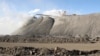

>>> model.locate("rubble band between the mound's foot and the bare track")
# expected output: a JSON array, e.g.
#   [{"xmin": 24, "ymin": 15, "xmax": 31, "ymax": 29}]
[{"xmin": 0, "ymin": 35, "xmax": 100, "ymax": 43}]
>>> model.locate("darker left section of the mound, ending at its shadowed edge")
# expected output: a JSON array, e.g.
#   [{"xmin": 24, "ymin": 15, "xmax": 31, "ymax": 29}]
[{"xmin": 14, "ymin": 17, "xmax": 54, "ymax": 35}]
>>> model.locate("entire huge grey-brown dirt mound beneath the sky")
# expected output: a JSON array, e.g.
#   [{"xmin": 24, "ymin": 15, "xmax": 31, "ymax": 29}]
[{"xmin": 14, "ymin": 14, "xmax": 100, "ymax": 37}]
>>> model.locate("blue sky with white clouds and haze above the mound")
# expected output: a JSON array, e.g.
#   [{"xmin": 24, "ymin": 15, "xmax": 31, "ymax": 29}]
[{"xmin": 0, "ymin": 0, "xmax": 100, "ymax": 34}]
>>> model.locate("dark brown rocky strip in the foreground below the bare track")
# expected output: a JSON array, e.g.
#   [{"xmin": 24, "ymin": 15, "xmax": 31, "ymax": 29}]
[{"xmin": 0, "ymin": 47, "xmax": 100, "ymax": 56}]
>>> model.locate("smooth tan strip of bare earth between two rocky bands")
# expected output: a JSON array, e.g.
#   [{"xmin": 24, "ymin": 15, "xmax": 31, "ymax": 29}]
[{"xmin": 0, "ymin": 43, "xmax": 100, "ymax": 51}]
